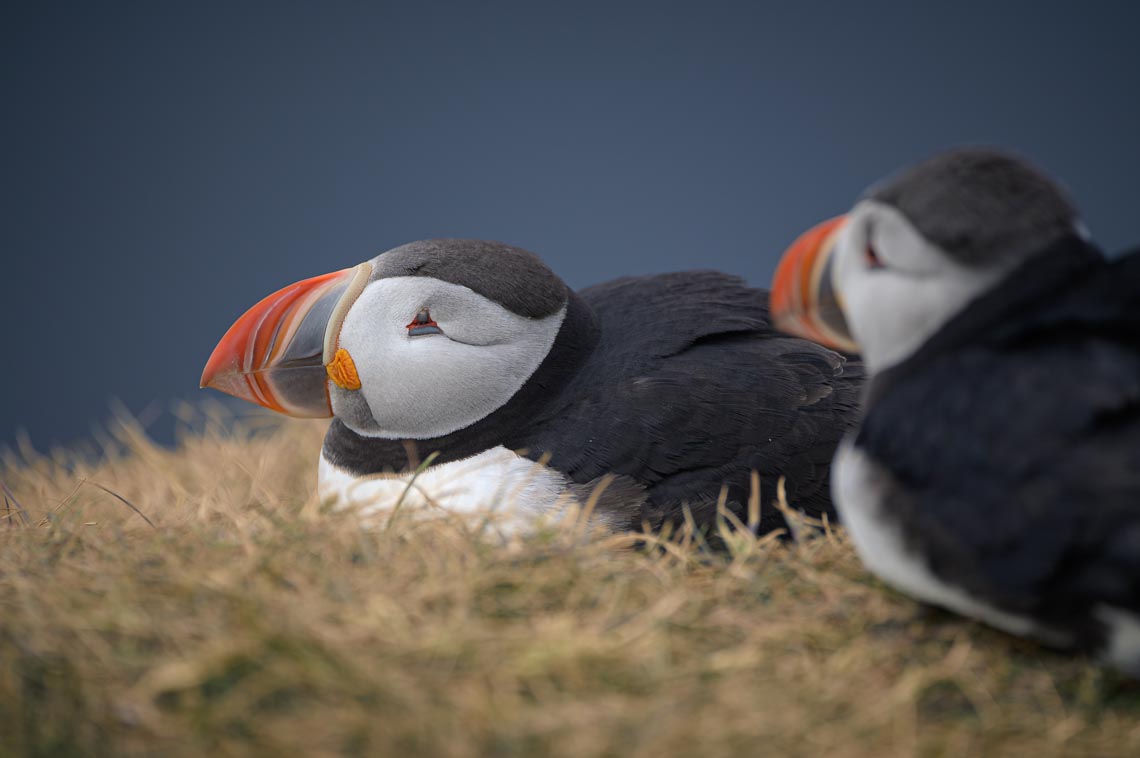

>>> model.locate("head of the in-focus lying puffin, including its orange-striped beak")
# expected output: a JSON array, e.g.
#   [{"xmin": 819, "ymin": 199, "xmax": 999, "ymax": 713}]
[{"xmin": 202, "ymin": 239, "xmax": 570, "ymax": 439}]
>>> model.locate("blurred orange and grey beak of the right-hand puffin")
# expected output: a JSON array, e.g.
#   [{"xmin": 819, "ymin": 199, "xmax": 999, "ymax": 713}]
[{"xmin": 771, "ymin": 215, "xmax": 858, "ymax": 352}]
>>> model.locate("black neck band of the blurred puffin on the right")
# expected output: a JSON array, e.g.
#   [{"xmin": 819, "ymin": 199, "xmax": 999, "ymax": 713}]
[{"xmin": 864, "ymin": 234, "xmax": 1106, "ymax": 408}]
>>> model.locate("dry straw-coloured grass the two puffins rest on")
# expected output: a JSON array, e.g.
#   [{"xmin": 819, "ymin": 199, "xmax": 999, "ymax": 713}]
[{"xmin": 0, "ymin": 410, "xmax": 1140, "ymax": 757}]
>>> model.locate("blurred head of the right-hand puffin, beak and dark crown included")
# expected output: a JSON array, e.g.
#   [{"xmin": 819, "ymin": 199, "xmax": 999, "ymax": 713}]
[{"xmin": 772, "ymin": 148, "xmax": 1086, "ymax": 372}]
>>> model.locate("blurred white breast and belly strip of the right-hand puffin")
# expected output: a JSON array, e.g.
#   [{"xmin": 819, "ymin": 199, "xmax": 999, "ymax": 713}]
[{"xmin": 831, "ymin": 438, "xmax": 1067, "ymax": 646}]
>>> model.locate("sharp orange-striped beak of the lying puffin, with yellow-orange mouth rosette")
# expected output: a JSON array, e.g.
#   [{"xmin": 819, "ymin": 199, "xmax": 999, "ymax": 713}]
[{"xmin": 201, "ymin": 263, "xmax": 372, "ymax": 418}]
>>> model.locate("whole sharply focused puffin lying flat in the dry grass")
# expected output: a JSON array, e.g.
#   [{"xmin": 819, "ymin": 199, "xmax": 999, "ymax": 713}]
[{"xmin": 201, "ymin": 239, "xmax": 863, "ymax": 532}]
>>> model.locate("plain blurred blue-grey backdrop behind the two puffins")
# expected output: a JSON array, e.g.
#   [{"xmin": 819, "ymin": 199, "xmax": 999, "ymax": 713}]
[{"xmin": 0, "ymin": 0, "xmax": 1140, "ymax": 448}]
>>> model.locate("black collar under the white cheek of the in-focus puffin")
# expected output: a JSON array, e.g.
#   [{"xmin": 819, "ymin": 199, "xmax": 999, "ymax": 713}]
[{"xmin": 323, "ymin": 292, "xmax": 600, "ymax": 475}]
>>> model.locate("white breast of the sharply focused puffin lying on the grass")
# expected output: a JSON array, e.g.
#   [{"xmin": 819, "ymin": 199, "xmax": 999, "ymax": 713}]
[{"xmin": 317, "ymin": 447, "xmax": 577, "ymax": 531}]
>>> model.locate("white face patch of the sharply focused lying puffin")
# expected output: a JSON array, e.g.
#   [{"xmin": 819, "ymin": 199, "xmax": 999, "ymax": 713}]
[{"xmin": 333, "ymin": 277, "xmax": 565, "ymax": 439}]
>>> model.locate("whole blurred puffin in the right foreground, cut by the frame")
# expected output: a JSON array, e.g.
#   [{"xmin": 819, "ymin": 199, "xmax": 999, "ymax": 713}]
[{"xmin": 772, "ymin": 147, "xmax": 1140, "ymax": 676}]
